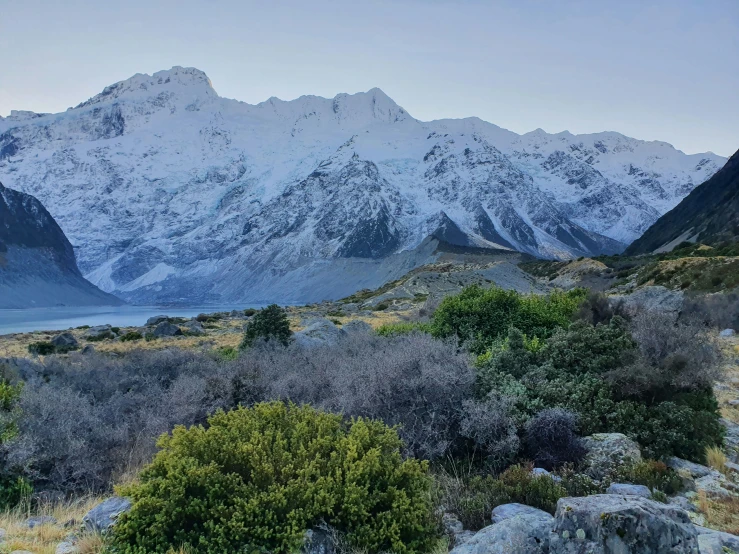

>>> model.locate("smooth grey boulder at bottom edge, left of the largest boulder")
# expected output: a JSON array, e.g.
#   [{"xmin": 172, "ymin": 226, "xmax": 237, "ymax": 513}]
[{"xmin": 451, "ymin": 512, "xmax": 553, "ymax": 554}]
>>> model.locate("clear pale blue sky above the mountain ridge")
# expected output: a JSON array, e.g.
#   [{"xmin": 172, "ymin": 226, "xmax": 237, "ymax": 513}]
[{"xmin": 0, "ymin": 0, "xmax": 739, "ymax": 156}]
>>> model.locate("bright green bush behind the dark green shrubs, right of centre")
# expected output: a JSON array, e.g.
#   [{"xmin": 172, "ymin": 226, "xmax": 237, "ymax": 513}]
[{"xmin": 433, "ymin": 285, "xmax": 585, "ymax": 353}]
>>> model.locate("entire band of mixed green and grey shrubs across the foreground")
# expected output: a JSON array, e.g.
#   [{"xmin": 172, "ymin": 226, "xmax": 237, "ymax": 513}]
[{"xmin": 0, "ymin": 287, "xmax": 723, "ymax": 554}]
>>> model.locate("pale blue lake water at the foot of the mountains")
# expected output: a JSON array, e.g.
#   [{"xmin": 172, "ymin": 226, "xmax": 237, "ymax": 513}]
[{"xmin": 0, "ymin": 305, "xmax": 259, "ymax": 335}]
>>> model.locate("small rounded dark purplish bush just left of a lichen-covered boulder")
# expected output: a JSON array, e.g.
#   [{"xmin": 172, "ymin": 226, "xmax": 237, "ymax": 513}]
[{"xmin": 524, "ymin": 408, "xmax": 585, "ymax": 471}]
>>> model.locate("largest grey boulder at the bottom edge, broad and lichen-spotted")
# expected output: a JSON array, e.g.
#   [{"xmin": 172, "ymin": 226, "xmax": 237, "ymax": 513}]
[{"xmin": 549, "ymin": 494, "xmax": 699, "ymax": 554}]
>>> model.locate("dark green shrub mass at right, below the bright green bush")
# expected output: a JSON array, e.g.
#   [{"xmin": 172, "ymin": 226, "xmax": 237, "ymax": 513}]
[{"xmin": 478, "ymin": 317, "xmax": 723, "ymax": 462}]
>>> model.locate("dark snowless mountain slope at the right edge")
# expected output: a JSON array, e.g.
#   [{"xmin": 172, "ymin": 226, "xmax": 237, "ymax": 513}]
[{"xmin": 627, "ymin": 151, "xmax": 739, "ymax": 254}]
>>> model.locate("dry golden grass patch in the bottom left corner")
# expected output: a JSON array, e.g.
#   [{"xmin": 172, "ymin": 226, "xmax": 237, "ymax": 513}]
[{"xmin": 0, "ymin": 497, "xmax": 102, "ymax": 554}]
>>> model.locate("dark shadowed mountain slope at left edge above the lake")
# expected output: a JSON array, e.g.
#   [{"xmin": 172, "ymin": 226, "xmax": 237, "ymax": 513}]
[{"xmin": 0, "ymin": 183, "xmax": 122, "ymax": 308}]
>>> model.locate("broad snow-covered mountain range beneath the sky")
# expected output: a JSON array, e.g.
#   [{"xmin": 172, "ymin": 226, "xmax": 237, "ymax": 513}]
[{"xmin": 0, "ymin": 67, "xmax": 726, "ymax": 302}]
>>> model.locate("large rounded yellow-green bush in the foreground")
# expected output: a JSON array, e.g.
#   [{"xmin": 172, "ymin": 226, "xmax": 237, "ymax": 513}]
[{"xmin": 112, "ymin": 402, "xmax": 435, "ymax": 554}]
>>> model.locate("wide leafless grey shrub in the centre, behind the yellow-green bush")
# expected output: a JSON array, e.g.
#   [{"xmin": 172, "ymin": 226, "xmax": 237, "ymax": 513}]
[{"xmin": 260, "ymin": 333, "xmax": 475, "ymax": 459}]
